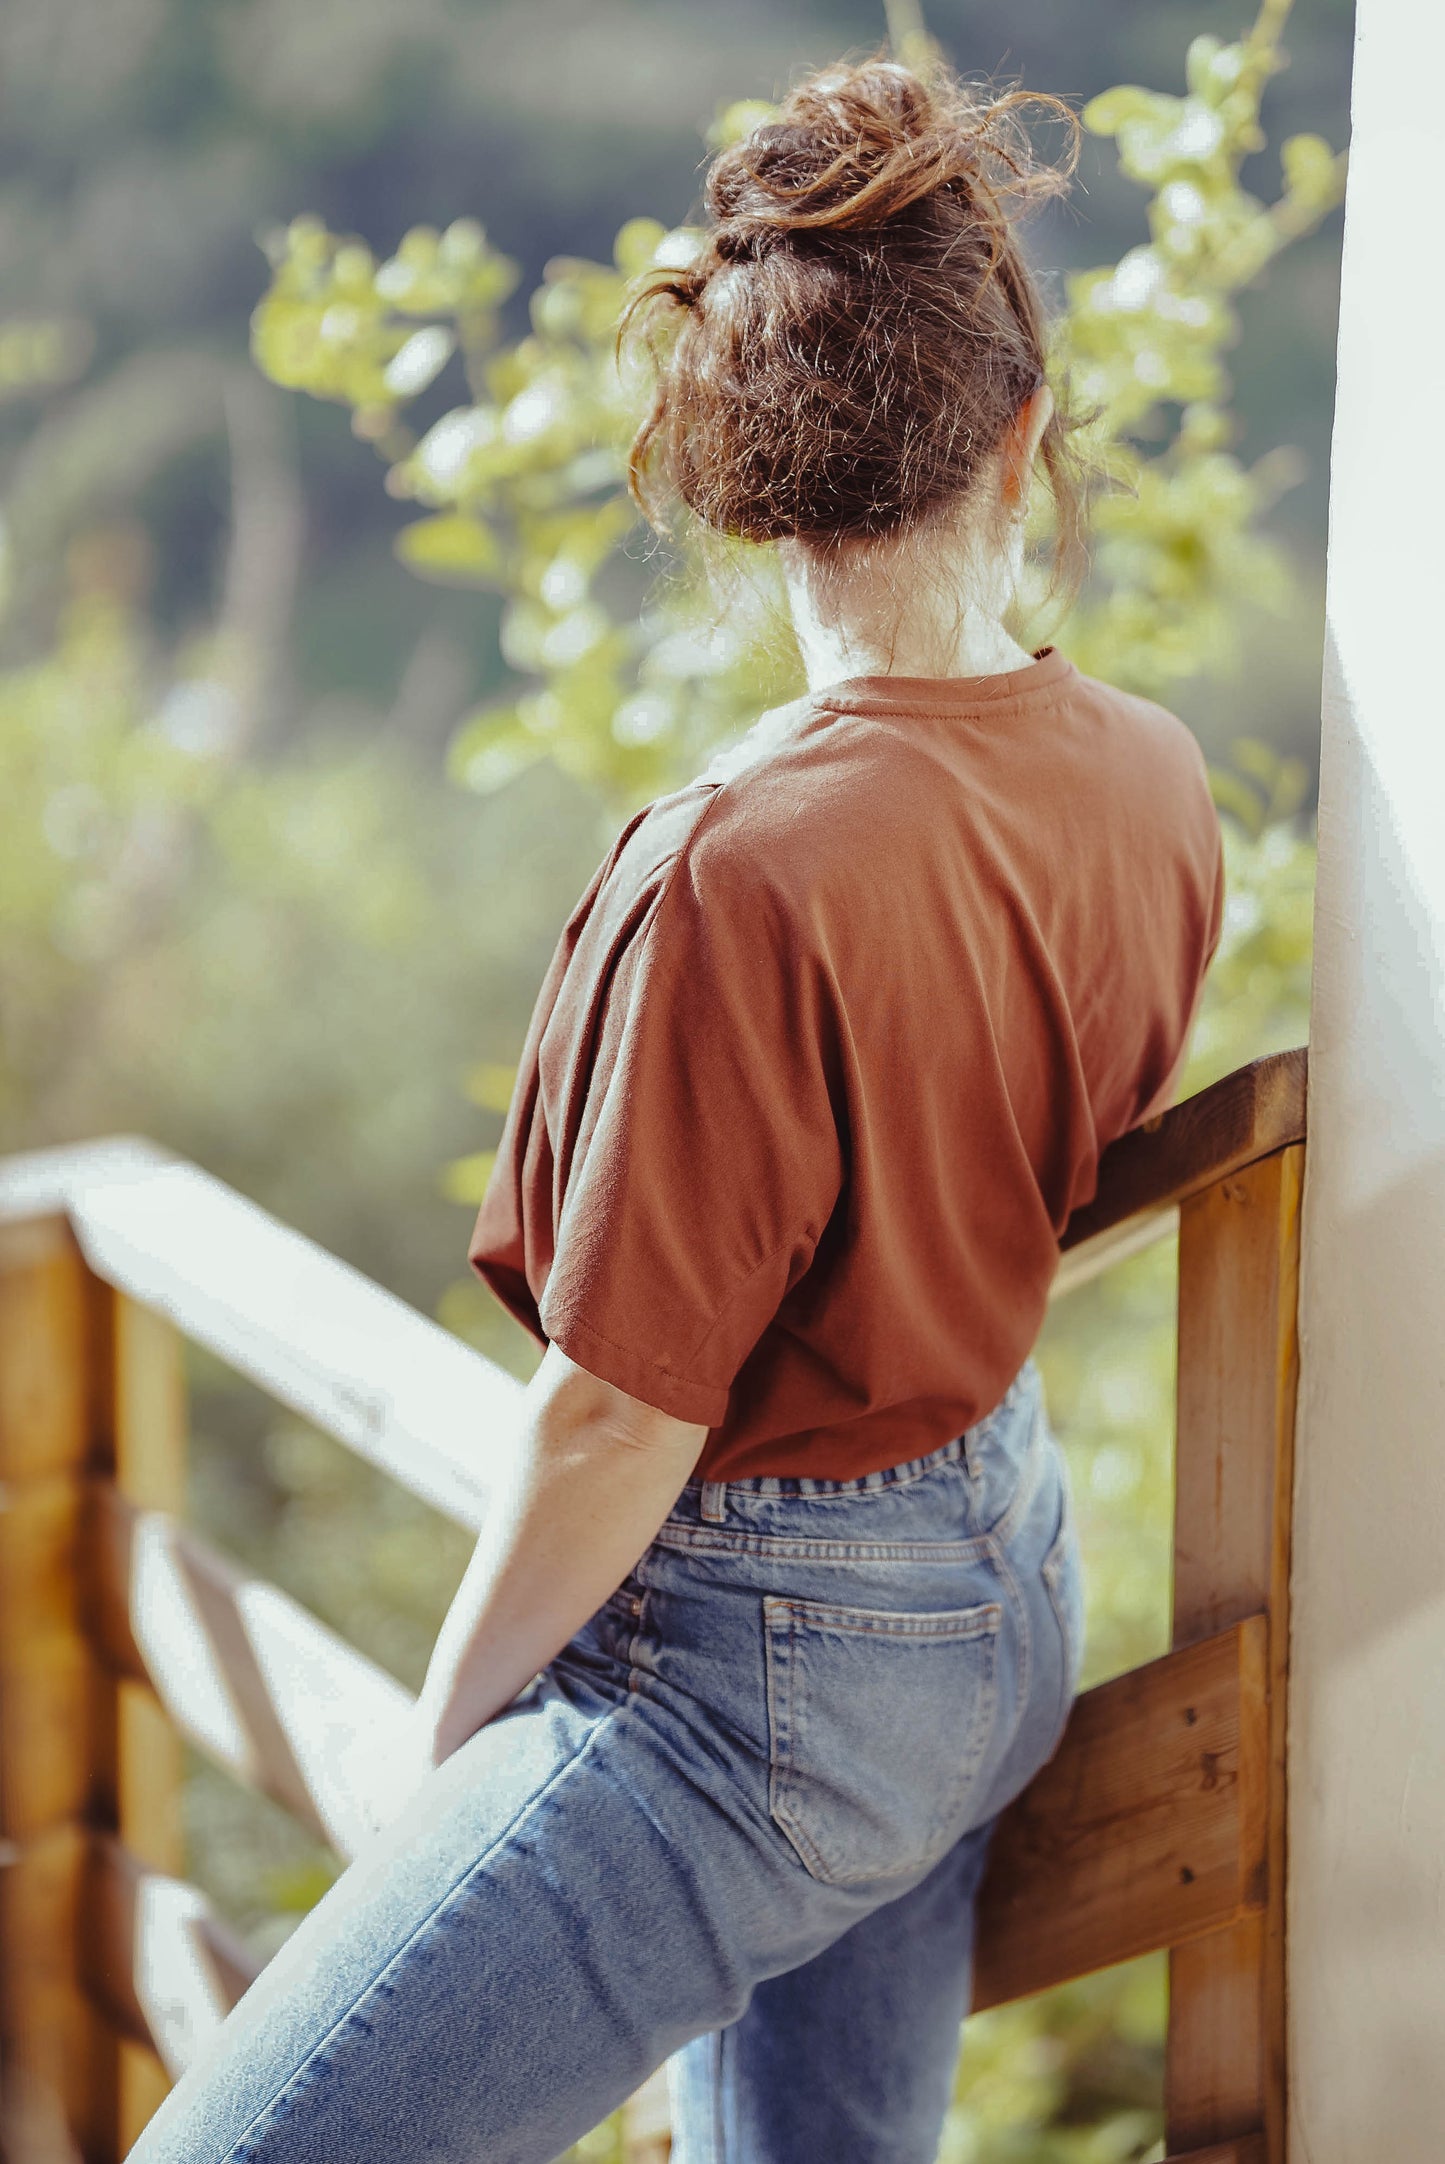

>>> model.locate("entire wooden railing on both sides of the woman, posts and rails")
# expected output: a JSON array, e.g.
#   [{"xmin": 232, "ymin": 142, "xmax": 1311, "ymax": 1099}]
[{"xmin": 0, "ymin": 1052, "xmax": 1304, "ymax": 2164}]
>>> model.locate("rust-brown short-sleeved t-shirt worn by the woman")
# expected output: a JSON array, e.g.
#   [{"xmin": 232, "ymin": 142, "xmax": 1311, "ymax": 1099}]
[{"xmin": 469, "ymin": 647, "xmax": 1224, "ymax": 1480}]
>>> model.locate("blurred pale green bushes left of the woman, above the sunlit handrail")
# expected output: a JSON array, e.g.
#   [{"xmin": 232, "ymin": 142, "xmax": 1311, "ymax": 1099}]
[{"xmin": 0, "ymin": 549, "xmax": 599, "ymax": 1307}]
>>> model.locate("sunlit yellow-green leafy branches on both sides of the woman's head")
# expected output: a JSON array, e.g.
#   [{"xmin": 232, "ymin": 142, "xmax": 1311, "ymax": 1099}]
[{"xmin": 253, "ymin": 0, "xmax": 1343, "ymax": 809}]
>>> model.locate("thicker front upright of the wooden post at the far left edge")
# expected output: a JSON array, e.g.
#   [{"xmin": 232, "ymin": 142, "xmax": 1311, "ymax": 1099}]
[{"xmin": 0, "ymin": 1220, "xmax": 119, "ymax": 2164}]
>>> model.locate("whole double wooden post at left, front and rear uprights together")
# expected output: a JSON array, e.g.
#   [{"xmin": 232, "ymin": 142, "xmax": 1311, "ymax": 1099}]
[{"xmin": 0, "ymin": 1218, "xmax": 184, "ymax": 2164}]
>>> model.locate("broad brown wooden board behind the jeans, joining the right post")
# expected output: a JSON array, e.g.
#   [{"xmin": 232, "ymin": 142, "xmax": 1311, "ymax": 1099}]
[{"xmin": 973, "ymin": 1617, "xmax": 1268, "ymax": 2008}]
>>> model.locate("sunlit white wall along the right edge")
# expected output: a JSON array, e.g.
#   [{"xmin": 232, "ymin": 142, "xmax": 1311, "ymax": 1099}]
[{"xmin": 1289, "ymin": 0, "xmax": 1445, "ymax": 2164}]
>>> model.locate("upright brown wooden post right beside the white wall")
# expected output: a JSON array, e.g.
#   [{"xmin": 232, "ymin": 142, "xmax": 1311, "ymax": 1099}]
[{"xmin": 1164, "ymin": 1143, "xmax": 1304, "ymax": 2164}]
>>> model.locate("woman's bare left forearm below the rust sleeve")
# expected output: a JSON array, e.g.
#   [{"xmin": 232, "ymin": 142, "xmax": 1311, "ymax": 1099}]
[{"xmin": 408, "ymin": 1344, "xmax": 707, "ymax": 1794}]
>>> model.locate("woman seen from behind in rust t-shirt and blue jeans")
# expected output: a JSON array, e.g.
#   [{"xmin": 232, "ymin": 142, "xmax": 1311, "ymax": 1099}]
[{"xmin": 134, "ymin": 46, "xmax": 1222, "ymax": 2164}]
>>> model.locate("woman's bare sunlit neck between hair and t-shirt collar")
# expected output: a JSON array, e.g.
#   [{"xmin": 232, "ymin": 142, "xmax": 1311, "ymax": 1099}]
[{"xmin": 781, "ymin": 515, "xmax": 1034, "ymax": 690}]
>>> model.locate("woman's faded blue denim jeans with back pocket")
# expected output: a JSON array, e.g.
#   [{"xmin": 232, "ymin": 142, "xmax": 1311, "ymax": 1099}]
[{"xmin": 132, "ymin": 1359, "xmax": 1084, "ymax": 2164}]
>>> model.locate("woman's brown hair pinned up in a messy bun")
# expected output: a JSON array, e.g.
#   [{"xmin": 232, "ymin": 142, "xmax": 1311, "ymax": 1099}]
[{"xmin": 619, "ymin": 56, "xmax": 1082, "ymax": 571}]
